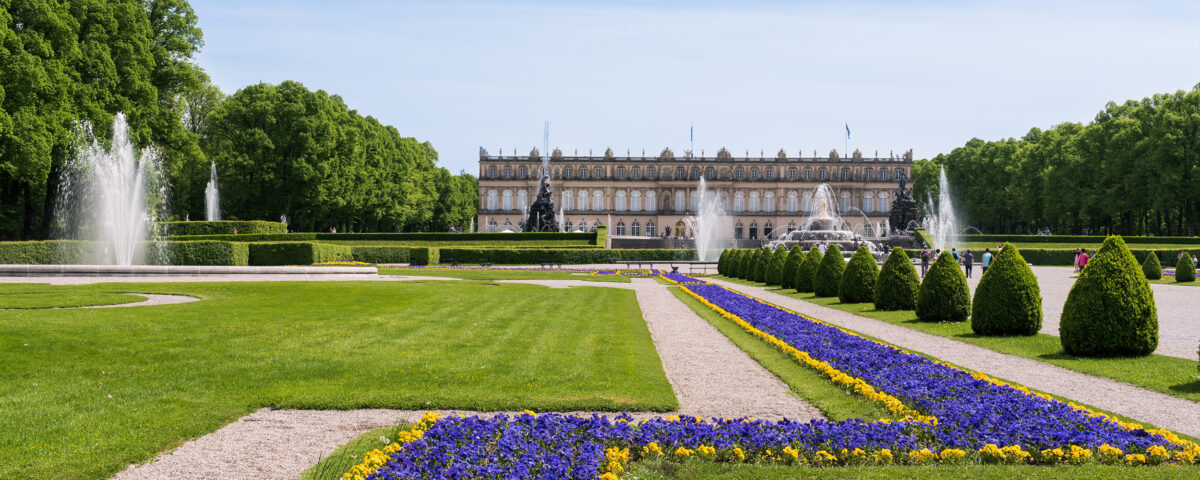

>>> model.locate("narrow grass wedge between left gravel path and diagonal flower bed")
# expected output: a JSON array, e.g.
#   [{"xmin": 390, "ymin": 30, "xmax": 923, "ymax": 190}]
[{"xmin": 671, "ymin": 287, "xmax": 892, "ymax": 420}]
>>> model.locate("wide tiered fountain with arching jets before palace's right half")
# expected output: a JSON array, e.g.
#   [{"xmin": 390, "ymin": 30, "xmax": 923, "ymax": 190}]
[{"xmin": 767, "ymin": 184, "xmax": 887, "ymax": 259}]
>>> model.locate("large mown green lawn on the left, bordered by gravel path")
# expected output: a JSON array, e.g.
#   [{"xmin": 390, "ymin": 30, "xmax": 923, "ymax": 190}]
[{"xmin": 0, "ymin": 282, "xmax": 677, "ymax": 479}]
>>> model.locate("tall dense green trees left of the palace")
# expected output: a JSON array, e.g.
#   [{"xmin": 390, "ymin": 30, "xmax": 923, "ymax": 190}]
[{"xmin": 0, "ymin": 0, "xmax": 476, "ymax": 240}]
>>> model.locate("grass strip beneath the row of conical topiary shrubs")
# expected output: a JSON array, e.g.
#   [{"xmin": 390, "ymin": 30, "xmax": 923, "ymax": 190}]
[{"xmin": 721, "ymin": 277, "xmax": 1200, "ymax": 402}]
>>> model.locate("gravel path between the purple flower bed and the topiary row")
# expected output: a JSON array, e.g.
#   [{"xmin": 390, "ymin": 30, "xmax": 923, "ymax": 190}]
[{"xmin": 713, "ymin": 280, "xmax": 1200, "ymax": 437}]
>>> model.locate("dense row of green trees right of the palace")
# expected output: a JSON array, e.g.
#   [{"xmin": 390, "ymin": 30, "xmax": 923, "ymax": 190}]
[{"xmin": 913, "ymin": 85, "xmax": 1200, "ymax": 235}]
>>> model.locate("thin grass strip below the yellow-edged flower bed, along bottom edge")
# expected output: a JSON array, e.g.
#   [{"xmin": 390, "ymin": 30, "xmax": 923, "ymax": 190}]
[{"xmin": 630, "ymin": 461, "xmax": 1200, "ymax": 480}]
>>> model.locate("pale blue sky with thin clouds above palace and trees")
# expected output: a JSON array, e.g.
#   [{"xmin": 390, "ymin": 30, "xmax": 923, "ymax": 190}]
[{"xmin": 191, "ymin": 0, "xmax": 1200, "ymax": 173}]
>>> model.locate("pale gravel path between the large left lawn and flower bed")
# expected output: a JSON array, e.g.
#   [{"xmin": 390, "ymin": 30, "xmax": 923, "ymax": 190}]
[{"xmin": 114, "ymin": 277, "xmax": 822, "ymax": 480}]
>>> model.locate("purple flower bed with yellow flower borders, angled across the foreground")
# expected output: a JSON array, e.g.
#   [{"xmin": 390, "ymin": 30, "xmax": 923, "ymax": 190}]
[{"xmin": 344, "ymin": 267, "xmax": 1200, "ymax": 480}]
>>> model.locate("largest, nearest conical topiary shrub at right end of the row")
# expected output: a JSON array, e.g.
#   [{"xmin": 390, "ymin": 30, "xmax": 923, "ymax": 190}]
[{"xmin": 1058, "ymin": 236, "xmax": 1158, "ymax": 356}]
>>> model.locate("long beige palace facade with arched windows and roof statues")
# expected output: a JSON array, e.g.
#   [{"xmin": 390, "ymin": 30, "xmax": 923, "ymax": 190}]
[{"xmin": 476, "ymin": 148, "xmax": 912, "ymax": 239}]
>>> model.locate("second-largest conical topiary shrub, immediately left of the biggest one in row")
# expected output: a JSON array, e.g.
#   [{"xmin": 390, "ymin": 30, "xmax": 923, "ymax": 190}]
[{"xmin": 971, "ymin": 244, "xmax": 1042, "ymax": 335}]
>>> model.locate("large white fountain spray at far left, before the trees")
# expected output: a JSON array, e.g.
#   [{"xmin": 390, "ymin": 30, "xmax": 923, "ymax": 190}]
[{"xmin": 55, "ymin": 114, "xmax": 167, "ymax": 265}]
